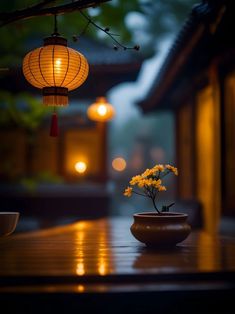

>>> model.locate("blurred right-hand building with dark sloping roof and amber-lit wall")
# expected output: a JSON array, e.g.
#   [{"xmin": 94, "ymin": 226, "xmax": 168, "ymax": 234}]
[{"xmin": 139, "ymin": 0, "xmax": 235, "ymax": 232}]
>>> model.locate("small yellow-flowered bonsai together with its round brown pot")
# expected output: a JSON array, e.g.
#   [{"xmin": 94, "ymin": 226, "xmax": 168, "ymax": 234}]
[{"xmin": 124, "ymin": 164, "xmax": 191, "ymax": 246}]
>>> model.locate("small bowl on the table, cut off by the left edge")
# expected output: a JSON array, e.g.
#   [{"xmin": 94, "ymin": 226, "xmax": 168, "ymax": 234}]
[{"xmin": 0, "ymin": 212, "xmax": 20, "ymax": 236}]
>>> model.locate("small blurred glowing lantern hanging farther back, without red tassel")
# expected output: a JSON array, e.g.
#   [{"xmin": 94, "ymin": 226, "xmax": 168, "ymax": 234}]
[{"xmin": 87, "ymin": 97, "xmax": 115, "ymax": 122}]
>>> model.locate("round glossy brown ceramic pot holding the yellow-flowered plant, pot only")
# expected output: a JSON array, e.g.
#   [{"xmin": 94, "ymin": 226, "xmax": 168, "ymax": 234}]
[{"xmin": 130, "ymin": 212, "xmax": 191, "ymax": 247}]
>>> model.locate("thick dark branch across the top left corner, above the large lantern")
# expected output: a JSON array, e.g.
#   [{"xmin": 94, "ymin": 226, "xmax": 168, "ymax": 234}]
[{"xmin": 0, "ymin": 0, "xmax": 110, "ymax": 27}]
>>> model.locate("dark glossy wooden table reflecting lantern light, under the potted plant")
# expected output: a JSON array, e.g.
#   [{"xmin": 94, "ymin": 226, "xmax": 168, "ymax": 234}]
[{"xmin": 0, "ymin": 218, "xmax": 235, "ymax": 314}]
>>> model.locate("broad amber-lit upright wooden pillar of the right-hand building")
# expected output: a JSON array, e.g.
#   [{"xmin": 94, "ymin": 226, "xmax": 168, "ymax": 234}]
[{"xmin": 195, "ymin": 66, "xmax": 221, "ymax": 233}]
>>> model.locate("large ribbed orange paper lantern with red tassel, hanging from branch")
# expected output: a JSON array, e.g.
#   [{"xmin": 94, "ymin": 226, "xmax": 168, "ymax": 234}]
[{"xmin": 23, "ymin": 16, "xmax": 89, "ymax": 136}]
